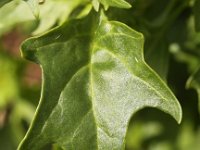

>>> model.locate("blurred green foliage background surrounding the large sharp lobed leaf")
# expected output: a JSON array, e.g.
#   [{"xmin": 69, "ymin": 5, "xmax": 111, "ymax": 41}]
[{"xmin": 0, "ymin": 0, "xmax": 200, "ymax": 150}]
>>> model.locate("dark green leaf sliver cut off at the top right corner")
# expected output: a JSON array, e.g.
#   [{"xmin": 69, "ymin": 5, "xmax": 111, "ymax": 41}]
[{"xmin": 194, "ymin": 0, "xmax": 200, "ymax": 32}]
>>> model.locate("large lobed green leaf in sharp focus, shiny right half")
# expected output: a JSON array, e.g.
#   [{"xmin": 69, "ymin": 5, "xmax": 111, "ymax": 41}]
[{"xmin": 19, "ymin": 12, "xmax": 182, "ymax": 150}]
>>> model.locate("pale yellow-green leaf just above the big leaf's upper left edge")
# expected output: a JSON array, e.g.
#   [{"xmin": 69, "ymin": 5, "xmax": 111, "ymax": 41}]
[{"xmin": 34, "ymin": 0, "xmax": 87, "ymax": 34}]
